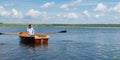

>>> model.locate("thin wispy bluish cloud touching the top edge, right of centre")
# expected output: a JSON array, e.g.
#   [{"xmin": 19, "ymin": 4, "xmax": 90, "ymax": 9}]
[{"xmin": 60, "ymin": 0, "xmax": 82, "ymax": 10}]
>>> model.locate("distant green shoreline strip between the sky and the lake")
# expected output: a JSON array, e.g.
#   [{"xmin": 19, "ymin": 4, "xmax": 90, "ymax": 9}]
[{"xmin": 0, "ymin": 24, "xmax": 120, "ymax": 28}]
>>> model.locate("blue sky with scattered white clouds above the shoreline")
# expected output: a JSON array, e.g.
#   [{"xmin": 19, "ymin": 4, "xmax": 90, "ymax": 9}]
[{"xmin": 0, "ymin": 0, "xmax": 120, "ymax": 24}]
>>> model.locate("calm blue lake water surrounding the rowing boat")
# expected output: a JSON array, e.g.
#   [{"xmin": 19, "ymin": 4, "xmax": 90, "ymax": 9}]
[{"xmin": 0, "ymin": 27, "xmax": 120, "ymax": 60}]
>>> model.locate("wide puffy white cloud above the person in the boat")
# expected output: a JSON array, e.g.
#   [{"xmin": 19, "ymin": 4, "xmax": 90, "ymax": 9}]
[{"xmin": 26, "ymin": 9, "xmax": 47, "ymax": 18}]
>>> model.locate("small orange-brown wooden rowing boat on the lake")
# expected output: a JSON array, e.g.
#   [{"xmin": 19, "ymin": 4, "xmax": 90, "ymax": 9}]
[{"xmin": 18, "ymin": 32, "xmax": 49, "ymax": 44}]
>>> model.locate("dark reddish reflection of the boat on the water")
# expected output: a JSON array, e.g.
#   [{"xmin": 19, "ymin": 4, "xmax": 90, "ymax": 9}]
[{"xmin": 20, "ymin": 40, "xmax": 49, "ymax": 50}]
